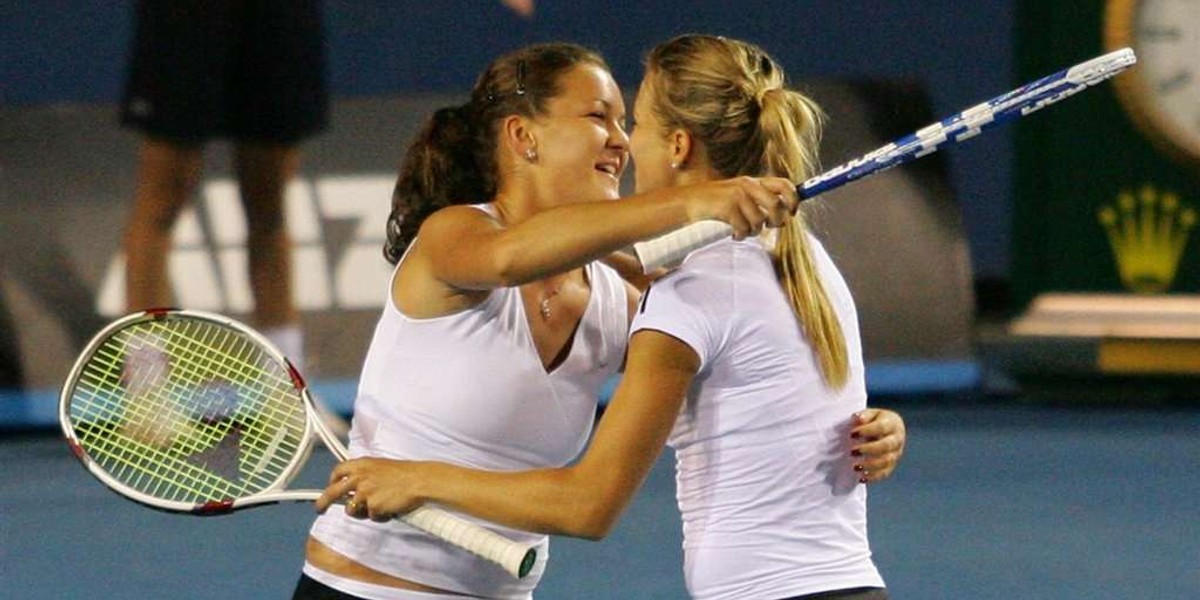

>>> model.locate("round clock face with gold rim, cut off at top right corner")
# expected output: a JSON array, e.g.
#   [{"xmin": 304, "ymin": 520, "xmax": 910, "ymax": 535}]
[{"xmin": 1105, "ymin": 0, "xmax": 1200, "ymax": 164}]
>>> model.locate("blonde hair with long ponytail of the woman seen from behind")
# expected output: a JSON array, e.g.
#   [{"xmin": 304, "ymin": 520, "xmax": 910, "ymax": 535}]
[{"xmin": 647, "ymin": 35, "xmax": 850, "ymax": 388}]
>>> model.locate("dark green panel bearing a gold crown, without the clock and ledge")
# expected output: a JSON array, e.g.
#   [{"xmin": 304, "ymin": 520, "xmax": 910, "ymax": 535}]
[{"xmin": 1010, "ymin": 0, "xmax": 1200, "ymax": 313}]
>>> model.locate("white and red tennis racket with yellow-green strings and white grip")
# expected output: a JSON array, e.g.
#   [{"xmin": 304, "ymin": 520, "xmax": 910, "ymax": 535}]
[{"xmin": 59, "ymin": 308, "xmax": 536, "ymax": 577}]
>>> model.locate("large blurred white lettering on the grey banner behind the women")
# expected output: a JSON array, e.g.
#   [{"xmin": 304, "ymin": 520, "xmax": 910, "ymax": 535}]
[{"xmin": 96, "ymin": 175, "xmax": 394, "ymax": 317}]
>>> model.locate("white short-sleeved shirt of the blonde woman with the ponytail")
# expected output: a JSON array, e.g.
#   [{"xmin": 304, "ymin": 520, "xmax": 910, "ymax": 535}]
[{"xmin": 632, "ymin": 236, "xmax": 883, "ymax": 600}]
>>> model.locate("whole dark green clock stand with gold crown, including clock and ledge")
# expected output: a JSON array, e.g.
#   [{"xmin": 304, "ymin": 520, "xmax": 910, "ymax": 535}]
[{"xmin": 1008, "ymin": 0, "xmax": 1200, "ymax": 374}]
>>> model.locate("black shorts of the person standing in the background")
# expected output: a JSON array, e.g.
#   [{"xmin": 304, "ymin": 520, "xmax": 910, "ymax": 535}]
[{"xmin": 121, "ymin": 0, "xmax": 329, "ymax": 144}]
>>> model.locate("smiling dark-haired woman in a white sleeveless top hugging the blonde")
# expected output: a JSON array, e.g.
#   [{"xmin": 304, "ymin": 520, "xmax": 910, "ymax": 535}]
[{"xmin": 295, "ymin": 43, "xmax": 797, "ymax": 599}]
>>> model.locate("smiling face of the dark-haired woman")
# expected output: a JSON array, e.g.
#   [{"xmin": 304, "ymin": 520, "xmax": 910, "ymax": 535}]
[{"xmin": 529, "ymin": 64, "xmax": 629, "ymax": 202}]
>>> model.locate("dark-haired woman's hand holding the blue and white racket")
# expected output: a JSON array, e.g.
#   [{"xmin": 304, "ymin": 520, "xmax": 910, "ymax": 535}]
[{"xmin": 679, "ymin": 176, "xmax": 800, "ymax": 240}]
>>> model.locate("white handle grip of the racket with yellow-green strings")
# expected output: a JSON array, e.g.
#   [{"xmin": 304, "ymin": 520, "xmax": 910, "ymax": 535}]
[{"xmin": 400, "ymin": 506, "xmax": 538, "ymax": 578}]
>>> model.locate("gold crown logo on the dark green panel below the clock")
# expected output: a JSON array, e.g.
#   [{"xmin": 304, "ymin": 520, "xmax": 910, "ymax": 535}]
[{"xmin": 1097, "ymin": 186, "xmax": 1196, "ymax": 294}]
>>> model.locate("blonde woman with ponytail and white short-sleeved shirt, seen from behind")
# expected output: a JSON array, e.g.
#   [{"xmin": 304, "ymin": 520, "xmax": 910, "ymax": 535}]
[{"xmin": 318, "ymin": 35, "xmax": 904, "ymax": 600}]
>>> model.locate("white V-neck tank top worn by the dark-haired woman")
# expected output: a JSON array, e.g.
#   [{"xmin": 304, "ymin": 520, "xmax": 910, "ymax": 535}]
[{"xmin": 311, "ymin": 205, "xmax": 629, "ymax": 599}]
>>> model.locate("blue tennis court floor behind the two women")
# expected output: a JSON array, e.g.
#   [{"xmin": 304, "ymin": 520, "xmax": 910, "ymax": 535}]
[{"xmin": 0, "ymin": 397, "xmax": 1200, "ymax": 600}]
